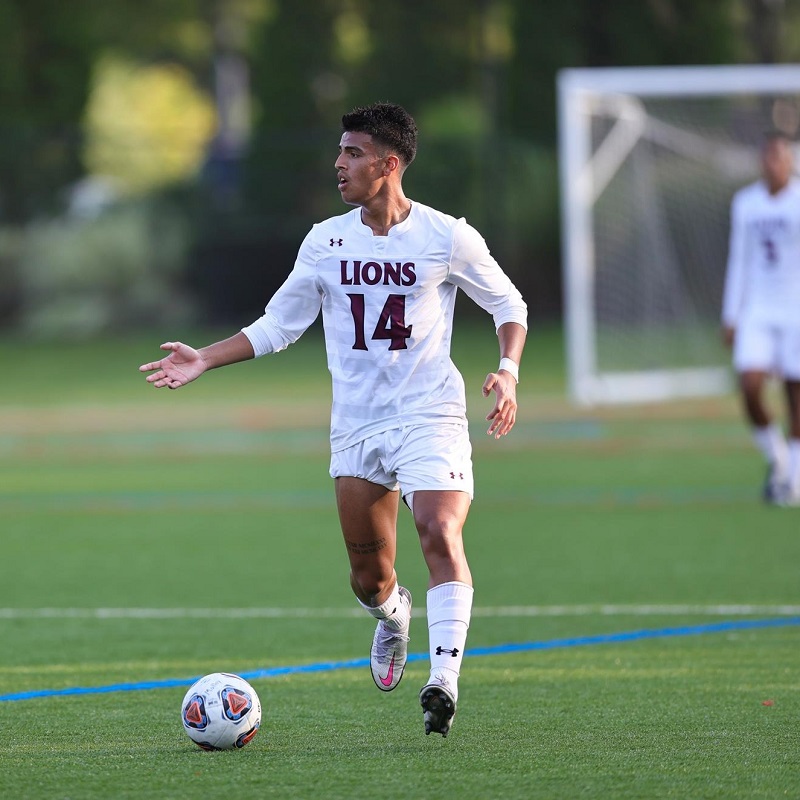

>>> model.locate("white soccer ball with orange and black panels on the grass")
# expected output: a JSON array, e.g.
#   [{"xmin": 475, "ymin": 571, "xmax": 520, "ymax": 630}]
[{"xmin": 181, "ymin": 672, "xmax": 261, "ymax": 750}]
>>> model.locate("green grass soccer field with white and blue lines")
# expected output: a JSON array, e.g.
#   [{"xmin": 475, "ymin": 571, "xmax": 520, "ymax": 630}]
[{"xmin": 0, "ymin": 324, "xmax": 800, "ymax": 800}]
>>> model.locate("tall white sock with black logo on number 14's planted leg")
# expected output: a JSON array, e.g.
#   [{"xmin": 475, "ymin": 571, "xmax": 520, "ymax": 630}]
[{"xmin": 428, "ymin": 581, "xmax": 473, "ymax": 698}]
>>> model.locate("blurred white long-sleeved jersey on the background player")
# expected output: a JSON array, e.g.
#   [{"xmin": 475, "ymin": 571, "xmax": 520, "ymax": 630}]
[{"xmin": 722, "ymin": 178, "xmax": 800, "ymax": 327}]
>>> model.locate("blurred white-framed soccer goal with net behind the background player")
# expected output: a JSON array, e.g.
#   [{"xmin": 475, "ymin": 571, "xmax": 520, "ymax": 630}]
[{"xmin": 558, "ymin": 65, "xmax": 800, "ymax": 405}]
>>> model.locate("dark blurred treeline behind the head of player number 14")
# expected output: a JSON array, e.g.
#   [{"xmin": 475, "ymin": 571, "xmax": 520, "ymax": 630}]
[{"xmin": 0, "ymin": 0, "xmax": 800, "ymax": 324}]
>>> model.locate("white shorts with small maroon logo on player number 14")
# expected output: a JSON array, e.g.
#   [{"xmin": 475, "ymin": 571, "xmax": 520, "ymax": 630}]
[{"xmin": 330, "ymin": 422, "xmax": 474, "ymax": 499}]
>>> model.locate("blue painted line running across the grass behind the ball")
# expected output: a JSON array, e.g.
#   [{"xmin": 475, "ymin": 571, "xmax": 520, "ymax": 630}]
[{"xmin": 0, "ymin": 617, "xmax": 800, "ymax": 703}]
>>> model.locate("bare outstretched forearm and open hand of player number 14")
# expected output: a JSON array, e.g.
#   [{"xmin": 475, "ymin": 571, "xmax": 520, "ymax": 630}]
[{"xmin": 139, "ymin": 333, "xmax": 255, "ymax": 389}]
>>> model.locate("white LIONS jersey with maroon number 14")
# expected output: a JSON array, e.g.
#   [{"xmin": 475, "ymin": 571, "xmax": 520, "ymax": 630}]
[{"xmin": 242, "ymin": 203, "xmax": 527, "ymax": 452}]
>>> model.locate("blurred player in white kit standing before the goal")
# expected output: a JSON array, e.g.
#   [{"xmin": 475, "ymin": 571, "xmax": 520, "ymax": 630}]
[{"xmin": 722, "ymin": 134, "xmax": 800, "ymax": 506}]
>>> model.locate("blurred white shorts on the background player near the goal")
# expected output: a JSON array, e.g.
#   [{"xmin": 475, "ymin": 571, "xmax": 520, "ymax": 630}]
[{"xmin": 733, "ymin": 322, "xmax": 800, "ymax": 380}]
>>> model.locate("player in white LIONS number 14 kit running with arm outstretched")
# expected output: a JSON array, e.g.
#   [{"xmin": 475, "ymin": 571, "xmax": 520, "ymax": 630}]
[{"xmin": 140, "ymin": 103, "xmax": 527, "ymax": 736}]
